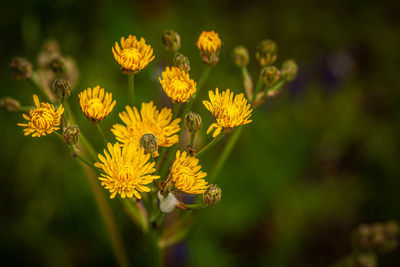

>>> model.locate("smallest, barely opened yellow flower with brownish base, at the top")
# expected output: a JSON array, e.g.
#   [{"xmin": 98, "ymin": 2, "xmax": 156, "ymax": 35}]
[{"xmin": 197, "ymin": 31, "xmax": 222, "ymax": 65}]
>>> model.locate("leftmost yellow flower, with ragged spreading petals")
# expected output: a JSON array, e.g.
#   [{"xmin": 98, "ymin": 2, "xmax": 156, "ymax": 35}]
[{"xmin": 18, "ymin": 95, "xmax": 64, "ymax": 137}]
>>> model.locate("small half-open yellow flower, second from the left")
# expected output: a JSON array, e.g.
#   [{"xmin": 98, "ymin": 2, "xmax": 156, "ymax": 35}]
[{"xmin": 79, "ymin": 85, "xmax": 116, "ymax": 123}]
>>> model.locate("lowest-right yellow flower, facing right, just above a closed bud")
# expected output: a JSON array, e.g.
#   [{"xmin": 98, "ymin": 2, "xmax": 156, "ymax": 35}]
[{"xmin": 171, "ymin": 150, "xmax": 207, "ymax": 195}]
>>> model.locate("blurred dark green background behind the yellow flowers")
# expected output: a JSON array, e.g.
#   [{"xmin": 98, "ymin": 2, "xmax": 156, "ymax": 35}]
[{"xmin": 0, "ymin": 0, "xmax": 400, "ymax": 266}]
